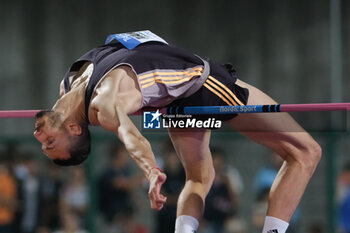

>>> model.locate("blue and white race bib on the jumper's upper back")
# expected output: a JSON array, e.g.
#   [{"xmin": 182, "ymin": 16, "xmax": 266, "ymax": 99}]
[{"xmin": 105, "ymin": 30, "xmax": 168, "ymax": 49}]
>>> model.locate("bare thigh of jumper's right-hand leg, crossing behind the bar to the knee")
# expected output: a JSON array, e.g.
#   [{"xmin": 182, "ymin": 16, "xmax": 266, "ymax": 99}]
[{"xmin": 228, "ymin": 80, "xmax": 313, "ymax": 157}]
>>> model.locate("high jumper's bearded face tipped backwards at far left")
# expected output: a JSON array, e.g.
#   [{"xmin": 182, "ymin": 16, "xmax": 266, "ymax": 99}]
[{"xmin": 34, "ymin": 112, "xmax": 70, "ymax": 159}]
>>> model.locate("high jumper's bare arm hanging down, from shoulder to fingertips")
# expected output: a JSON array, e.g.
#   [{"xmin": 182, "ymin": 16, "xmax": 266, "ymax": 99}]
[{"xmin": 90, "ymin": 66, "xmax": 166, "ymax": 210}]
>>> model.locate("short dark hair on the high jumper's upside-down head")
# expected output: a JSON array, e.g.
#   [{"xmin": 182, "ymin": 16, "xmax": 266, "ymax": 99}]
[{"xmin": 53, "ymin": 124, "xmax": 91, "ymax": 166}]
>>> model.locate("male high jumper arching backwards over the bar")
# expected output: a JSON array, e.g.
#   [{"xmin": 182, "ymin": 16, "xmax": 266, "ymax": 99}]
[{"xmin": 34, "ymin": 32, "xmax": 321, "ymax": 233}]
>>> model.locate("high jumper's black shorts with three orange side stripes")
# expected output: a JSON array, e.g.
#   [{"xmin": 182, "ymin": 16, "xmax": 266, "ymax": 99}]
[{"xmin": 168, "ymin": 61, "xmax": 249, "ymax": 121}]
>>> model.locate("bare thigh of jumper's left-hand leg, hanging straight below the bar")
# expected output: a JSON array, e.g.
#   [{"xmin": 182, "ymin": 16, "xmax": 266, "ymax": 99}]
[{"xmin": 169, "ymin": 129, "xmax": 212, "ymax": 179}]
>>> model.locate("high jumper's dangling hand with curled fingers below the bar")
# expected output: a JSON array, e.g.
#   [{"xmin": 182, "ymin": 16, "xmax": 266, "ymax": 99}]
[{"xmin": 148, "ymin": 169, "xmax": 166, "ymax": 210}]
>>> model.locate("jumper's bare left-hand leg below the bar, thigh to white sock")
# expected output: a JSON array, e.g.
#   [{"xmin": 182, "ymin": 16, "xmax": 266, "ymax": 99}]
[{"xmin": 171, "ymin": 131, "xmax": 215, "ymax": 233}]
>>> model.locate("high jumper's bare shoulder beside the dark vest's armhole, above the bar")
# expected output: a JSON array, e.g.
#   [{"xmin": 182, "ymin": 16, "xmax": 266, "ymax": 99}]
[{"xmin": 89, "ymin": 65, "xmax": 142, "ymax": 124}]
